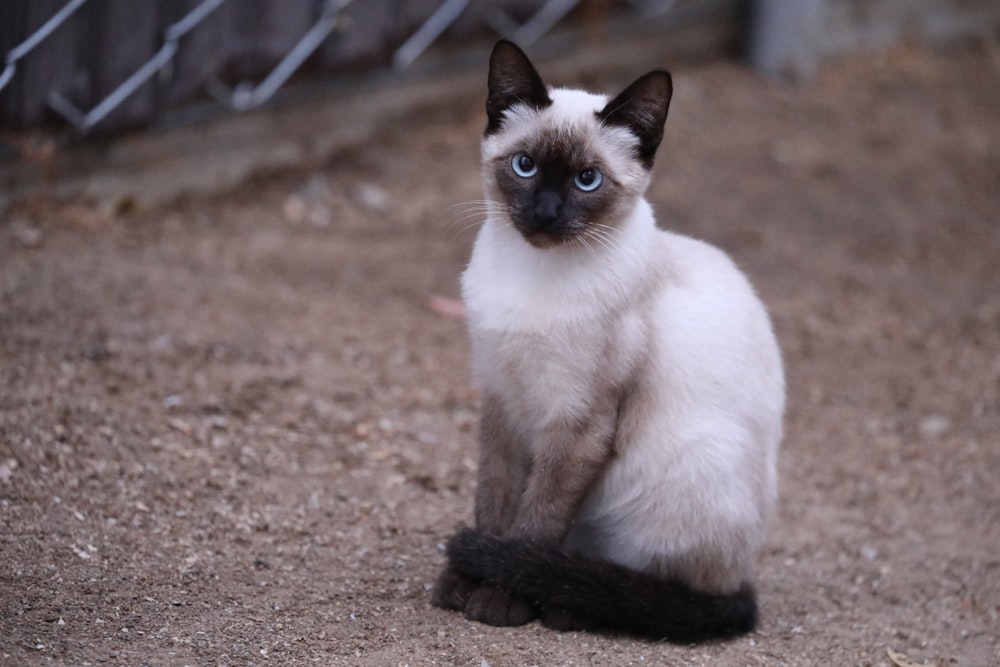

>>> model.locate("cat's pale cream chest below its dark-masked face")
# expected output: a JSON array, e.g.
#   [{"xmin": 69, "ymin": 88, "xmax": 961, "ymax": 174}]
[{"xmin": 462, "ymin": 219, "xmax": 649, "ymax": 423}]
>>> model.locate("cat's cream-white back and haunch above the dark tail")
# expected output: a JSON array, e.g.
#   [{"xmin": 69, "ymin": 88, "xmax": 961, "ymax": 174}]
[{"xmin": 570, "ymin": 232, "xmax": 785, "ymax": 590}]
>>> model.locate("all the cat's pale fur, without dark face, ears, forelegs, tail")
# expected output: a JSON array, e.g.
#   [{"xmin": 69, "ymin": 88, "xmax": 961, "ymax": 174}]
[{"xmin": 462, "ymin": 90, "xmax": 785, "ymax": 591}]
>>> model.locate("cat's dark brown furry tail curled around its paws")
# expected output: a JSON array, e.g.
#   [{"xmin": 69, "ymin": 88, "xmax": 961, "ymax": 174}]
[{"xmin": 447, "ymin": 529, "xmax": 757, "ymax": 643}]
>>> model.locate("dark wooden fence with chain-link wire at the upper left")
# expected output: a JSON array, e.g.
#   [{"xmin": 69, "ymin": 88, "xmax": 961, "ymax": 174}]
[{"xmin": 0, "ymin": 0, "xmax": 716, "ymax": 132}]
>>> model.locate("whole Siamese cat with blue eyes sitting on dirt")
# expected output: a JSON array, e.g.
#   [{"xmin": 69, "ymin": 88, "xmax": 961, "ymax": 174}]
[{"xmin": 433, "ymin": 41, "xmax": 785, "ymax": 642}]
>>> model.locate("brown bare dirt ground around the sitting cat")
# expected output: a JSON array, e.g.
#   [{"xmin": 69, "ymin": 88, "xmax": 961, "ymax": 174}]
[{"xmin": 0, "ymin": 37, "xmax": 1000, "ymax": 667}]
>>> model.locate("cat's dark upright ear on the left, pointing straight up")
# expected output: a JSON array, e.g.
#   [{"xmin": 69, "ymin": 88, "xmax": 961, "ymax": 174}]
[{"xmin": 486, "ymin": 39, "xmax": 552, "ymax": 134}]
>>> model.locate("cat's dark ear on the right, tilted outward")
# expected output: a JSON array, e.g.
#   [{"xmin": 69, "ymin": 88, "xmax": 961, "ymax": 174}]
[{"xmin": 597, "ymin": 70, "xmax": 674, "ymax": 169}]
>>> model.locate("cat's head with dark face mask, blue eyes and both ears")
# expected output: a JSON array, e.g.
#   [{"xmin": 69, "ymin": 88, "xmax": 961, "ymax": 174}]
[{"xmin": 482, "ymin": 40, "xmax": 673, "ymax": 248}]
